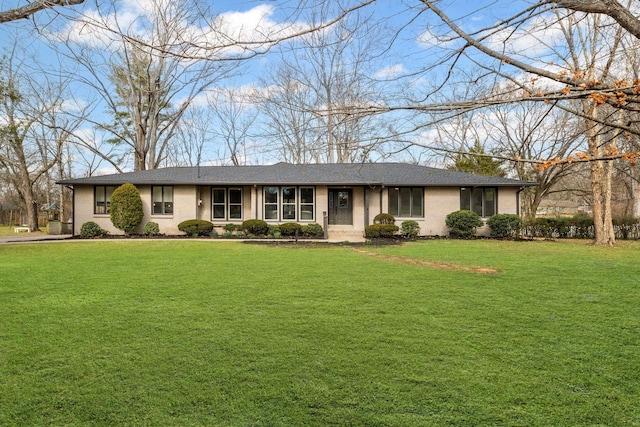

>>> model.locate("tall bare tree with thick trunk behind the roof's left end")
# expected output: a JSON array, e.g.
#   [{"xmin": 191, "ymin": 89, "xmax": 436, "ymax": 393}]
[{"xmin": 57, "ymin": 0, "xmax": 244, "ymax": 170}]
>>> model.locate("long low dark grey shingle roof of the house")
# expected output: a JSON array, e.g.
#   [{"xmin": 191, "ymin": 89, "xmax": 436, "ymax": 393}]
[{"xmin": 58, "ymin": 163, "xmax": 537, "ymax": 187}]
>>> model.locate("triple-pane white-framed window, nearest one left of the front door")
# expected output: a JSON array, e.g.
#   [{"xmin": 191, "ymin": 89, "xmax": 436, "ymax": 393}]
[{"xmin": 264, "ymin": 187, "xmax": 315, "ymax": 221}]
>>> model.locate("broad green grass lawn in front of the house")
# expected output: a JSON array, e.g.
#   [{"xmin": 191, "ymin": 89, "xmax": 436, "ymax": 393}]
[{"xmin": 0, "ymin": 240, "xmax": 640, "ymax": 426}]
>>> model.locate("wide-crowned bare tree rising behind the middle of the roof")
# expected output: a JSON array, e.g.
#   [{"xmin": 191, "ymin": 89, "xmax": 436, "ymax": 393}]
[{"xmin": 263, "ymin": 5, "xmax": 384, "ymax": 163}]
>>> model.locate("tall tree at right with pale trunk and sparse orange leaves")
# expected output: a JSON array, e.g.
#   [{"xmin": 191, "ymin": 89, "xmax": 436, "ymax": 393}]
[{"xmin": 342, "ymin": 0, "xmax": 640, "ymax": 245}]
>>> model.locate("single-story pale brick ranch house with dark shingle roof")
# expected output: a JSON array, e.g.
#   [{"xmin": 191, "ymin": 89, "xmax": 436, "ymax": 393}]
[{"xmin": 59, "ymin": 163, "xmax": 536, "ymax": 240}]
